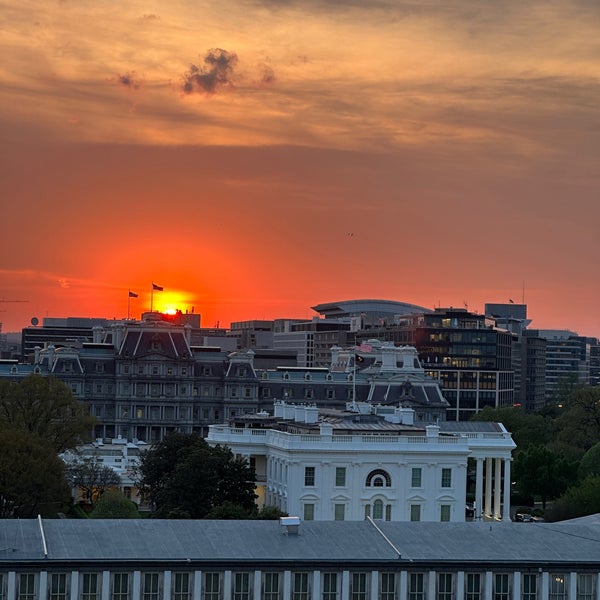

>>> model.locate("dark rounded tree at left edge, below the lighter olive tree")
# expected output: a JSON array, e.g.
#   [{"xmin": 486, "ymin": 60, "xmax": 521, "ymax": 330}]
[{"xmin": 0, "ymin": 431, "xmax": 71, "ymax": 518}]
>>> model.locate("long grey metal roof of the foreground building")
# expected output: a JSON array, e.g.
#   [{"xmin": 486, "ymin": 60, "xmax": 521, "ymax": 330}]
[{"xmin": 0, "ymin": 518, "xmax": 600, "ymax": 570}]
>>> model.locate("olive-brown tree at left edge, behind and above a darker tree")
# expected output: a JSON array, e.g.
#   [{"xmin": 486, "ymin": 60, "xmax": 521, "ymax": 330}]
[{"xmin": 0, "ymin": 375, "xmax": 95, "ymax": 452}]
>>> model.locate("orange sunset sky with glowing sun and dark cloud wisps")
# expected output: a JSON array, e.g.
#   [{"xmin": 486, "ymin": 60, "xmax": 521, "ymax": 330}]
[{"xmin": 0, "ymin": 0, "xmax": 600, "ymax": 336}]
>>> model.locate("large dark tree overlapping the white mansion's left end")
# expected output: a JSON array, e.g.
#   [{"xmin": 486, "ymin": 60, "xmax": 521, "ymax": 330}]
[{"xmin": 138, "ymin": 433, "xmax": 256, "ymax": 519}]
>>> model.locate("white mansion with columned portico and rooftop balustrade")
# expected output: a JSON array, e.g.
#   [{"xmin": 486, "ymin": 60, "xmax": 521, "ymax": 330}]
[{"xmin": 207, "ymin": 402, "xmax": 515, "ymax": 521}]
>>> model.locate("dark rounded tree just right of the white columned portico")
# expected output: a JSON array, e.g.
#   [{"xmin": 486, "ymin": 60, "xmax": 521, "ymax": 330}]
[{"xmin": 513, "ymin": 445, "xmax": 577, "ymax": 509}]
